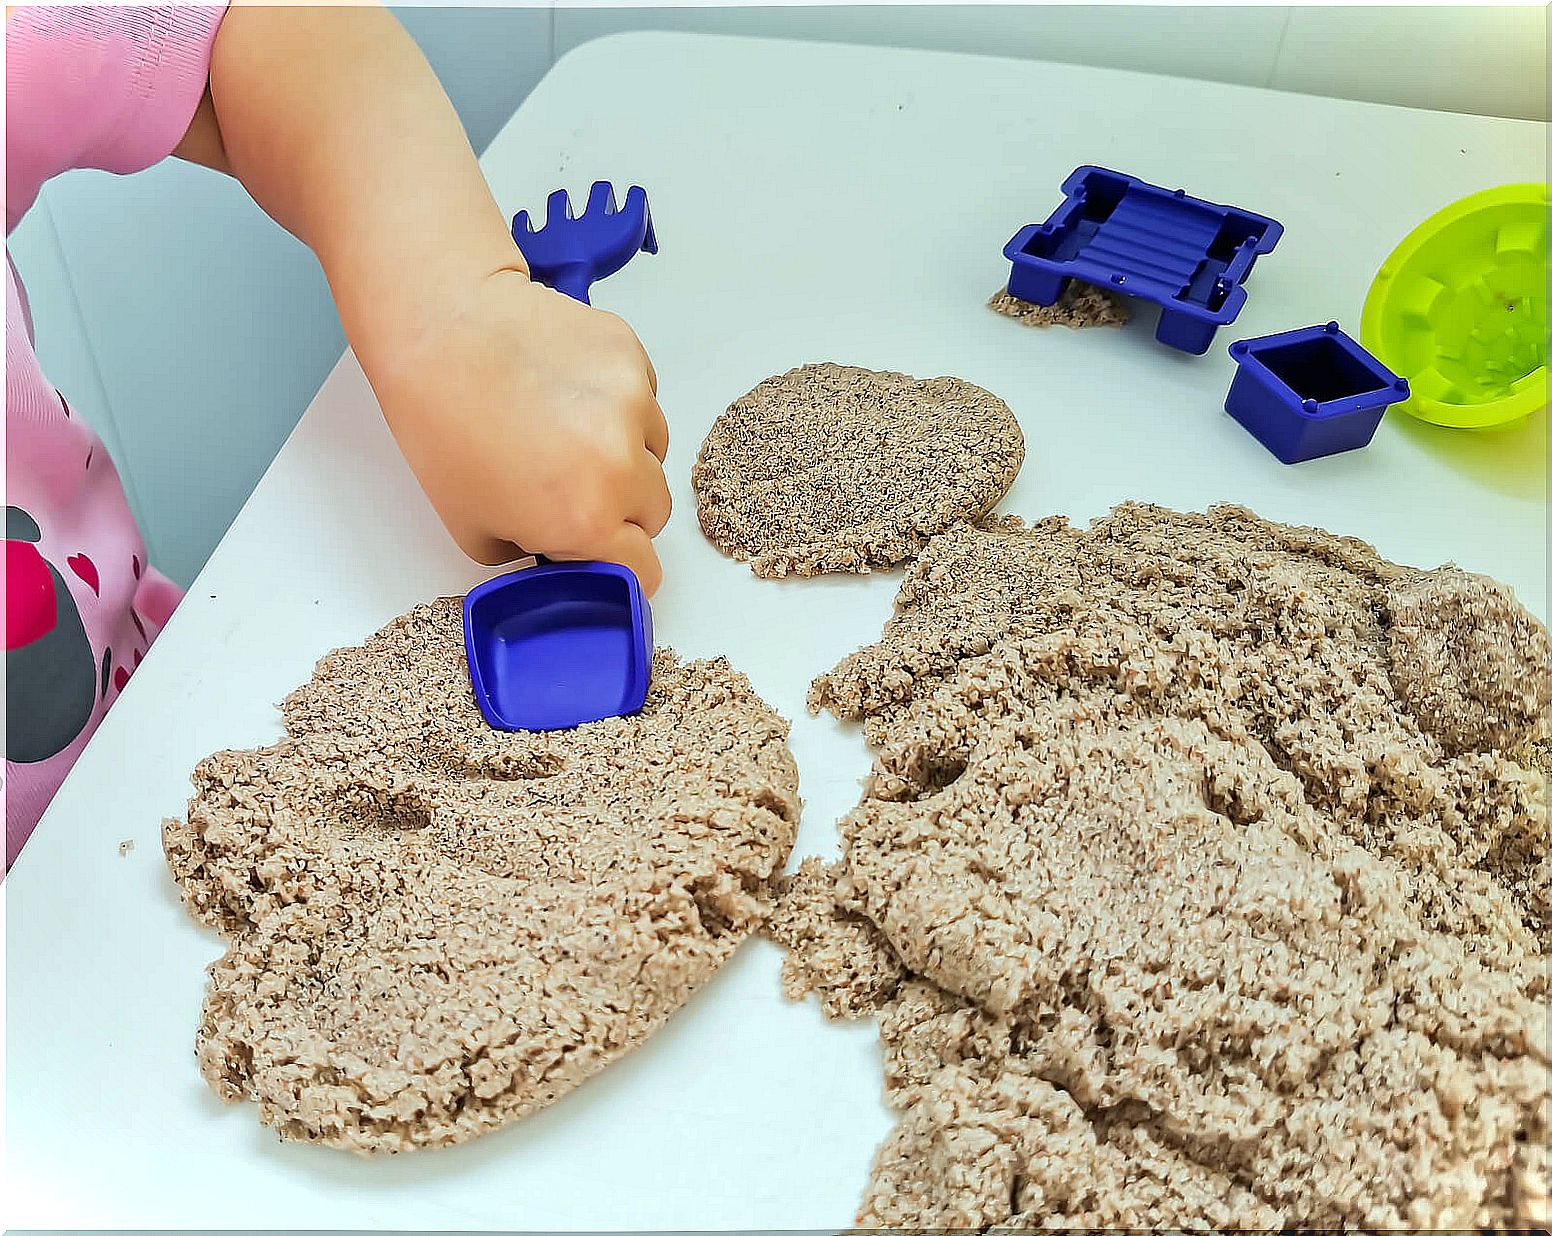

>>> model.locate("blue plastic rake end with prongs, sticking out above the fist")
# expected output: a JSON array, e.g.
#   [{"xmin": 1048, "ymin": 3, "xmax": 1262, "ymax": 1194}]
[{"xmin": 512, "ymin": 180, "xmax": 658, "ymax": 304}]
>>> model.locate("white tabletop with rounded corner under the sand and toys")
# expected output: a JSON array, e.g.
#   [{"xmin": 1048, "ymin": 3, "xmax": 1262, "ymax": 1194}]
[{"xmin": 0, "ymin": 34, "xmax": 1546, "ymax": 1230}]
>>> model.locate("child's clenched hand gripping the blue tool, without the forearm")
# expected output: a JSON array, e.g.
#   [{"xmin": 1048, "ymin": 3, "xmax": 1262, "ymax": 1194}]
[{"xmin": 368, "ymin": 270, "xmax": 672, "ymax": 595}]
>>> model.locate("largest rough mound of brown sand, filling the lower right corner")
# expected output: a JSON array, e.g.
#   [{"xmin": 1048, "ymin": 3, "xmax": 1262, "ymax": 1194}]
[{"xmin": 767, "ymin": 505, "xmax": 1552, "ymax": 1228}]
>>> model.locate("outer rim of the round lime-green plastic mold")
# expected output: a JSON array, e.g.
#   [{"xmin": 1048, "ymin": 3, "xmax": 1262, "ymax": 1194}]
[{"xmin": 1358, "ymin": 182, "xmax": 1549, "ymax": 429}]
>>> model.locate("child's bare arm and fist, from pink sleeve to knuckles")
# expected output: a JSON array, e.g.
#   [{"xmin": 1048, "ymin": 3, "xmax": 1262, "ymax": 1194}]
[{"xmin": 180, "ymin": 6, "xmax": 670, "ymax": 592}]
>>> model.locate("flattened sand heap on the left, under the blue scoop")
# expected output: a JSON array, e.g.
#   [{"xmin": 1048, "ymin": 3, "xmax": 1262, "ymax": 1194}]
[{"xmin": 163, "ymin": 599, "xmax": 799, "ymax": 1152}]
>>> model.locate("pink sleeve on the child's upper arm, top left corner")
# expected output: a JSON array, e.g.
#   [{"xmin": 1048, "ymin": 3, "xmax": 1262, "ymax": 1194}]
[{"xmin": 5, "ymin": 5, "xmax": 227, "ymax": 234}]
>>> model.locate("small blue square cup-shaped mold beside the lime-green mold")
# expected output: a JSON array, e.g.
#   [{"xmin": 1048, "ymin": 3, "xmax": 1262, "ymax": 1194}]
[{"xmin": 1223, "ymin": 321, "xmax": 1409, "ymax": 463}]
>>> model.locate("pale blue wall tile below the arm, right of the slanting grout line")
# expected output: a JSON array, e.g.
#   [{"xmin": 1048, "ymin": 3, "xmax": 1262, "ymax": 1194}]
[{"xmin": 39, "ymin": 160, "xmax": 345, "ymax": 584}]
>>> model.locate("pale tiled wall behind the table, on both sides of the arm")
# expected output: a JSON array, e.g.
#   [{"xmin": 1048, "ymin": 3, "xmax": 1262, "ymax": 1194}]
[{"xmin": 9, "ymin": 5, "xmax": 1547, "ymax": 582}]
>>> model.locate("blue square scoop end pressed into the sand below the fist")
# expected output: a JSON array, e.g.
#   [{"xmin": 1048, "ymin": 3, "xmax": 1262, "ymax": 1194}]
[{"xmin": 464, "ymin": 562, "xmax": 652, "ymax": 730}]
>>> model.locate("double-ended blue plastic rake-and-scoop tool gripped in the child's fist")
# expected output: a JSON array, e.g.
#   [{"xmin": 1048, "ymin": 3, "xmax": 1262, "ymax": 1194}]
[{"xmin": 464, "ymin": 180, "xmax": 658, "ymax": 730}]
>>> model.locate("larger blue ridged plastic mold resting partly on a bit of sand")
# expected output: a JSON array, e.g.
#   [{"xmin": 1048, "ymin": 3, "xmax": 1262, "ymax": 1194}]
[{"xmin": 1003, "ymin": 168, "xmax": 1282, "ymax": 356}]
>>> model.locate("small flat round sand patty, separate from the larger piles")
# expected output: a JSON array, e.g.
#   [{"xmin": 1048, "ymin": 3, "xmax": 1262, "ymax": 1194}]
[{"xmin": 692, "ymin": 365, "xmax": 1024, "ymax": 578}]
